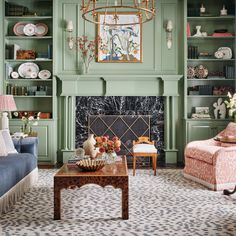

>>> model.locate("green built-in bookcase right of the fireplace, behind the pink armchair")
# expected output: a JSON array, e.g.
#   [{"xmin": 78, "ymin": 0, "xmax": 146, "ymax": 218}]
[{"xmin": 184, "ymin": 0, "xmax": 235, "ymax": 142}]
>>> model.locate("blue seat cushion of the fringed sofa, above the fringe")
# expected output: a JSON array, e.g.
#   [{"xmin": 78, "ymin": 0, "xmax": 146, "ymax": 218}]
[{"xmin": 0, "ymin": 153, "xmax": 37, "ymax": 197}]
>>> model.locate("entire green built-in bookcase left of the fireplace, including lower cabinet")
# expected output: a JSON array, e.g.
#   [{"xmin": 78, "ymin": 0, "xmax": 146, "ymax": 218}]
[{"xmin": 1, "ymin": 0, "xmax": 56, "ymax": 163}]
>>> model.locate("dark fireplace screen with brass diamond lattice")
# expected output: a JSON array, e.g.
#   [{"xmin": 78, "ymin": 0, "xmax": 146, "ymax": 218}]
[{"xmin": 88, "ymin": 115, "xmax": 150, "ymax": 155}]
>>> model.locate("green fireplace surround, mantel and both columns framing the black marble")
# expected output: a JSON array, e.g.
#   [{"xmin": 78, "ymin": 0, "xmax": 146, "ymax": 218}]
[{"xmin": 58, "ymin": 75, "xmax": 182, "ymax": 164}]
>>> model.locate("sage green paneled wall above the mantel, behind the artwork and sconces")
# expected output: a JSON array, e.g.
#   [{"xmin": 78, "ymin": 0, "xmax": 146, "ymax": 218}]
[{"xmin": 56, "ymin": 0, "xmax": 178, "ymax": 75}]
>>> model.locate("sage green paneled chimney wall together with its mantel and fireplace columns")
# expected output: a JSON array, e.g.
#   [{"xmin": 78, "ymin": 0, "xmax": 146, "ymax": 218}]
[{"xmin": 56, "ymin": 0, "xmax": 183, "ymax": 163}]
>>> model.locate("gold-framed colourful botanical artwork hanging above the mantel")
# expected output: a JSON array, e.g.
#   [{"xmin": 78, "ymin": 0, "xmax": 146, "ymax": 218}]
[{"xmin": 97, "ymin": 12, "xmax": 142, "ymax": 63}]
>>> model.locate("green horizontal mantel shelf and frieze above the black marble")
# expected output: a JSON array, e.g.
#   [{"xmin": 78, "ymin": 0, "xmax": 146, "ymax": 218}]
[{"xmin": 57, "ymin": 75, "xmax": 182, "ymax": 96}]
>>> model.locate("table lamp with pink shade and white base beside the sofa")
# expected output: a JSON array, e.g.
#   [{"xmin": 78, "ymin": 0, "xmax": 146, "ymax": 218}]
[{"xmin": 0, "ymin": 95, "xmax": 16, "ymax": 129}]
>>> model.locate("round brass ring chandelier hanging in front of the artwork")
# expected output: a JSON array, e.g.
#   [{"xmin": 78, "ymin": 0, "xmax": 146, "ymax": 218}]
[{"xmin": 81, "ymin": 0, "xmax": 155, "ymax": 26}]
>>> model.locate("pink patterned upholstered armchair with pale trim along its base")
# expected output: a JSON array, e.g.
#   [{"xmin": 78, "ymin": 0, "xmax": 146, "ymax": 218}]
[{"xmin": 183, "ymin": 122, "xmax": 236, "ymax": 190}]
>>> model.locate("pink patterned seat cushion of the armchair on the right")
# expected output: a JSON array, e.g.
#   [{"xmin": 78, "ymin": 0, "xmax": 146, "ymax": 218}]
[{"xmin": 185, "ymin": 141, "xmax": 223, "ymax": 164}]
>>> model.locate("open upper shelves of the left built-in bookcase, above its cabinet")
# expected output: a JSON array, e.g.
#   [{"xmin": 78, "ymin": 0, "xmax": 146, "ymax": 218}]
[{"xmin": 4, "ymin": 0, "xmax": 53, "ymax": 118}]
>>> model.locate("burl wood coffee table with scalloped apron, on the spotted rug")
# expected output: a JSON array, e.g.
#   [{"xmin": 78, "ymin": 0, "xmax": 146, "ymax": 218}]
[{"xmin": 54, "ymin": 156, "xmax": 129, "ymax": 220}]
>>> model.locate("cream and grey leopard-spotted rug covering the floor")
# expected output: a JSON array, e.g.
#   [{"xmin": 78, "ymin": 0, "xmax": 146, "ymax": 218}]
[{"xmin": 0, "ymin": 169, "xmax": 236, "ymax": 236}]
